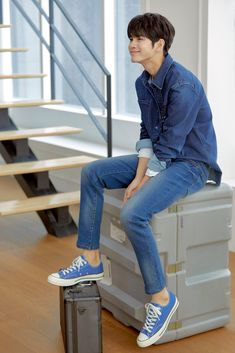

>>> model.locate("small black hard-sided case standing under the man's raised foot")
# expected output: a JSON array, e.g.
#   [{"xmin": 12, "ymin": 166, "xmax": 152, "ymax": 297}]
[{"xmin": 60, "ymin": 282, "xmax": 102, "ymax": 353}]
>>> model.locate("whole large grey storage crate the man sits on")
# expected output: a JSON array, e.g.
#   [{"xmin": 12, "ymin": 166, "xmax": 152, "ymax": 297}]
[{"xmin": 99, "ymin": 184, "xmax": 232, "ymax": 343}]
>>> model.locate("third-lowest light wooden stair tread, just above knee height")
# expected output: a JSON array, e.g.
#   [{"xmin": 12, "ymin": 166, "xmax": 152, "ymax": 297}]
[{"xmin": 0, "ymin": 126, "xmax": 82, "ymax": 141}]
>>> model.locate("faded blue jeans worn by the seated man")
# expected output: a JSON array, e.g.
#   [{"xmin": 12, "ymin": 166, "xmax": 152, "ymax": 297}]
[{"xmin": 77, "ymin": 154, "xmax": 209, "ymax": 294}]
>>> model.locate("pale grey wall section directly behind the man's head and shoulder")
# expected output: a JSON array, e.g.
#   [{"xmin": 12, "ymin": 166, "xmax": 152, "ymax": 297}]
[{"xmin": 146, "ymin": 0, "xmax": 208, "ymax": 87}]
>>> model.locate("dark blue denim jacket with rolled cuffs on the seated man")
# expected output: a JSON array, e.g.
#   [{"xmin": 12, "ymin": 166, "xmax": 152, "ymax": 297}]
[{"xmin": 136, "ymin": 54, "xmax": 222, "ymax": 185}]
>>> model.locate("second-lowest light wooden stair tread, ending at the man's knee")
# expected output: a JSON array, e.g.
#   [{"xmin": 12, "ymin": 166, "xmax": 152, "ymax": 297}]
[{"xmin": 0, "ymin": 156, "xmax": 95, "ymax": 176}]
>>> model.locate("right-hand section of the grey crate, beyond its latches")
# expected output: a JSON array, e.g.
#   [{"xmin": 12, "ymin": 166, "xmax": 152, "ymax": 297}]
[{"xmin": 176, "ymin": 184, "xmax": 232, "ymax": 338}]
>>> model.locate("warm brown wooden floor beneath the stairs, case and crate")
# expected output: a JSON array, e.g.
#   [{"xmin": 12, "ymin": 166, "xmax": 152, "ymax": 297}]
[{"xmin": 0, "ymin": 177, "xmax": 235, "ymax": 353}]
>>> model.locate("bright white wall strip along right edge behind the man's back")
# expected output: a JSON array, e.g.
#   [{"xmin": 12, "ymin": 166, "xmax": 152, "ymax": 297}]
[{"xmin": 207, "ymin": 0, "xmax": 235, "ymax": 180}]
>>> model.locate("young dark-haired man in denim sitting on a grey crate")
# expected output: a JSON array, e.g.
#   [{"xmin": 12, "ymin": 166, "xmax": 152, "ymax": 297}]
[{"xmin": 48, "ymin": 13, "xmax": 221, "ymax": 347}]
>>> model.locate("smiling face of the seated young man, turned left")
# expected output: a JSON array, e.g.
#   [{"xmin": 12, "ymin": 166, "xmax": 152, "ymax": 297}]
[{"xmin": 128, "ymin": 36, "xmax": 157, "ymax": 65}]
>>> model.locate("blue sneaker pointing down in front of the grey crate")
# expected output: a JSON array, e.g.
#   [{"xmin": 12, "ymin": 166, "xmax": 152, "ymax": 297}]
[{"xmin": 137, "ymin": 292, "xmax": 179, "ymax": 347}]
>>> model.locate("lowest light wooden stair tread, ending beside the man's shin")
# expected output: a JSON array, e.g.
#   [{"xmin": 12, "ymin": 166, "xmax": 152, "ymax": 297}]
[{"xmin": 0, "ymin": 191, "xmax": 80, "ymax": 216}]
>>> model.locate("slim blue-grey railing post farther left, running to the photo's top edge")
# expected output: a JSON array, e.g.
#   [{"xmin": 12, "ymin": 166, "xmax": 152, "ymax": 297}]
[{"xmin": 49, "ymin": 0, "xmax": 55, "ymax": 99}]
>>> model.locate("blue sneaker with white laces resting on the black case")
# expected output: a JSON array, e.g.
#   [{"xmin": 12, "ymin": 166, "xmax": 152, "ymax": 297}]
[{"xmin": 48, "ymin": 256, "xmax": 104, "ymax": 287}]
